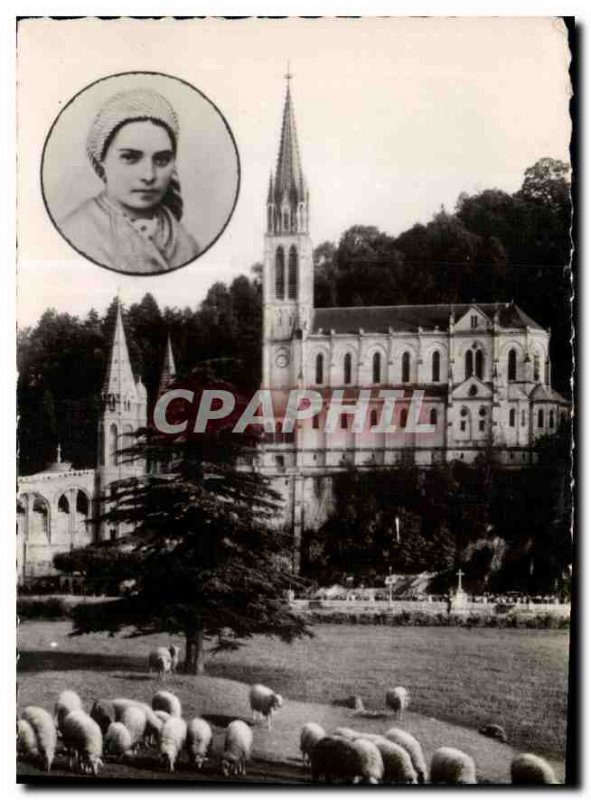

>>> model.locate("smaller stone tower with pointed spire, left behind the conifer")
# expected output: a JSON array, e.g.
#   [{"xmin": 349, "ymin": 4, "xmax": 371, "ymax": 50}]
[{"xmin": 97, "ymin": 302, "xmax": 148, "ymax": 538}]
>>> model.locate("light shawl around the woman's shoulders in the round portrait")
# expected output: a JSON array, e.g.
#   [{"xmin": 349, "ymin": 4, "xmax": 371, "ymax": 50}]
[{"xmin": 60, "ymin": 192, "xmax": 199, "ymax": 275}]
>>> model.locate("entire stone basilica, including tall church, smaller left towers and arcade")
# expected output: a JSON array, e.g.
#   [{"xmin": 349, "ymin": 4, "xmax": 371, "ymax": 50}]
[{"xmin": 17, "ymin": 79, "xmax": 569, "ymax": 582}]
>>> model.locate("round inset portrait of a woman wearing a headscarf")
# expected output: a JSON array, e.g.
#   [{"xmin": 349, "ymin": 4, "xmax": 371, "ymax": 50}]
[{"xmin": 42, "ymin": 73, "xmax": 239, "ymax": 275}]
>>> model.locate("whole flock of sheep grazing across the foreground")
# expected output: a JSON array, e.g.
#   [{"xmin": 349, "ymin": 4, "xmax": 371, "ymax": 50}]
[{"xmin": 17, "ymin": 647, "xmax": 558, "ymax": 785}]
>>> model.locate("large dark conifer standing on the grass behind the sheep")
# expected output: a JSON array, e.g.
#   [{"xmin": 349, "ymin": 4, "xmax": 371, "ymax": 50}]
[{"xmin": 55, "ymin": 375, "xmax": 311, "ymax": 674}]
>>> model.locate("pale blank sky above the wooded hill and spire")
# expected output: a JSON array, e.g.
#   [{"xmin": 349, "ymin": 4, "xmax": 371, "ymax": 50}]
[{"xmin": 17, "ymin": 17, "xmax": 570, "ymax": 326}]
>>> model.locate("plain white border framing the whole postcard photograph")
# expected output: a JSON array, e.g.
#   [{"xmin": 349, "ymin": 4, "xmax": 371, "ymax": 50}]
[{"xmin": 0, "ymin": 6, "xmax": 591, "ymax": 800}]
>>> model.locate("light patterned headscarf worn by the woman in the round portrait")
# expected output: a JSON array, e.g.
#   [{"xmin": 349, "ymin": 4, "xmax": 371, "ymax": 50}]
[{"xmin": 86, "ymin": 88, "xmax": 183, "ymax": 220}]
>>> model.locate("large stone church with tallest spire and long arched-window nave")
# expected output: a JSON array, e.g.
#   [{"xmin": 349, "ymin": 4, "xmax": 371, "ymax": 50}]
[{"xmin": 261, "ymin": 82, "xmax": 569, "ymax": 564}]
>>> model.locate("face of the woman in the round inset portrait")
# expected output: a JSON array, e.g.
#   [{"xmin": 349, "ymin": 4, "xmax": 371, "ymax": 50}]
[{"xmin": 102, "ymin": 120, "xmax": 175, "ymax": 216}]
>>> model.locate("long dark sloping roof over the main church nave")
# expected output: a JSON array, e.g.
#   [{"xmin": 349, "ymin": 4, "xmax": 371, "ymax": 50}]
[{"xmin": 312, "ymin": 303, "xmax": 543, "ymax": 333}]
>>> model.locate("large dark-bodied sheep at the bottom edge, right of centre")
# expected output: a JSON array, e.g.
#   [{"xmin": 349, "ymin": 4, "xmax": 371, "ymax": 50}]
[{"xmin": 311, "ymin": 736, "xmax": 374, "ymax": 783}]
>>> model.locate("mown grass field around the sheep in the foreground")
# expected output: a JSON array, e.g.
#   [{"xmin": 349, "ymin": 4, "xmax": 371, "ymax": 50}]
[{"xmin": 19, "ymin": 622, "xmax": 569, "ymax": 782}]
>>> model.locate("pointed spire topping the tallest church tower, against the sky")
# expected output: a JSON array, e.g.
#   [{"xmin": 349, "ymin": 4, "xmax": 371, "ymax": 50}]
[{"xmin": 267, "ymin": 69, "xmax": 308, "ymax": 234}]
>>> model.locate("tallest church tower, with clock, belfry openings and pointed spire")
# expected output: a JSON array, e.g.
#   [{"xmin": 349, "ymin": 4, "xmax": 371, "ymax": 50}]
[{"xmin": 263, "ymin": 72, "xmax": 314, "ymax": 388}]
